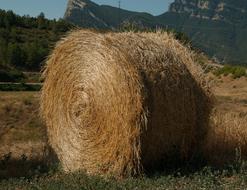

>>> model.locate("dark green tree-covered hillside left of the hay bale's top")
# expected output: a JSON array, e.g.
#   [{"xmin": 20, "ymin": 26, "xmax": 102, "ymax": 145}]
[{"xmin": 0, "ymin": 10, "xmax": 72, "ymax": 82}]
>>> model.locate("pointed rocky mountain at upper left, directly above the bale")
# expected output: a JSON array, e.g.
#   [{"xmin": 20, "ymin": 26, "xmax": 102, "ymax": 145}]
[{"xmin": 64, "ymin": 0, "xmax": 156, "ymax": 29}]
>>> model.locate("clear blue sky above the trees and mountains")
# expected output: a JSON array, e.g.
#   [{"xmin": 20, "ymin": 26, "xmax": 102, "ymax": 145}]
[{"xmin": 0, "ymin": 0, "xmax": 174, "ymax": 18}]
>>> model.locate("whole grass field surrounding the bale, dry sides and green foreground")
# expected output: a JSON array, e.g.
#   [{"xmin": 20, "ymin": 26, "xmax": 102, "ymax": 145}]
[{"xmin": 0, "ymin": 76, "xmax": 247, "ymax": 190}]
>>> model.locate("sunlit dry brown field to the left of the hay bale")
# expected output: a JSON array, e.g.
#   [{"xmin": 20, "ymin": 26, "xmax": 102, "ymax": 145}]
[{"xmin": 0, "ymin": 92, "xmax": 46, "ymax": 158}]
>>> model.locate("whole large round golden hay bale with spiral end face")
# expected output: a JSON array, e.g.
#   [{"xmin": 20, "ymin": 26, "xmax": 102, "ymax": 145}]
[{"xmin": 41, "ymin": 30, "xmax": 211, "ymax": 176}]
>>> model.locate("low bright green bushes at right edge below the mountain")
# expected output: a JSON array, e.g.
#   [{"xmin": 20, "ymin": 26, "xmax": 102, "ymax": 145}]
[{"xmin": 214, "ymin": 65, "xmax": 247, "ymax": 78}]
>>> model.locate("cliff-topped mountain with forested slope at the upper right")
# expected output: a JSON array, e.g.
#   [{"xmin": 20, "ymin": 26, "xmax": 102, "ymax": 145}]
[{"xmin": 159, "ymin": 0, "xmax": 247, "ymax": 64}]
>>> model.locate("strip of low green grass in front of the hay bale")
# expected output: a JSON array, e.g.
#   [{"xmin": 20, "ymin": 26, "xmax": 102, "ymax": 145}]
[{"xmin": 0, "ymin": 164, "xmax": 247, "ymax": 190}]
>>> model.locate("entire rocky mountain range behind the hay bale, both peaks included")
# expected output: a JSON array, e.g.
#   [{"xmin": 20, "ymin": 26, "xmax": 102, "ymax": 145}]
[{"xmin": 64, "ymin": 0, "xmax": 247, "ymax": 64}]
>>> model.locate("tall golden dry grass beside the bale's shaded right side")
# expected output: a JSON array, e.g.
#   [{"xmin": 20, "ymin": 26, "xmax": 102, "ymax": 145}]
[{"xmin": 204, "ymin": 111, "xmax": 247, "ymax": 166}]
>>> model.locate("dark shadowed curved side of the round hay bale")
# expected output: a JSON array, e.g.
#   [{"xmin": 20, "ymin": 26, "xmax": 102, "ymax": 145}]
[{"xmin": 141, "ymin": 65, "xmax": 215, "ymax": 175}]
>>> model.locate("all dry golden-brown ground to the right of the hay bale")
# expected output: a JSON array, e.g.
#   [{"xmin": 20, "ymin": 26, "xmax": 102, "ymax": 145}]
[{"xmin": 203, "ymin": 76, "xmax": 247, "ymax": 167}]
